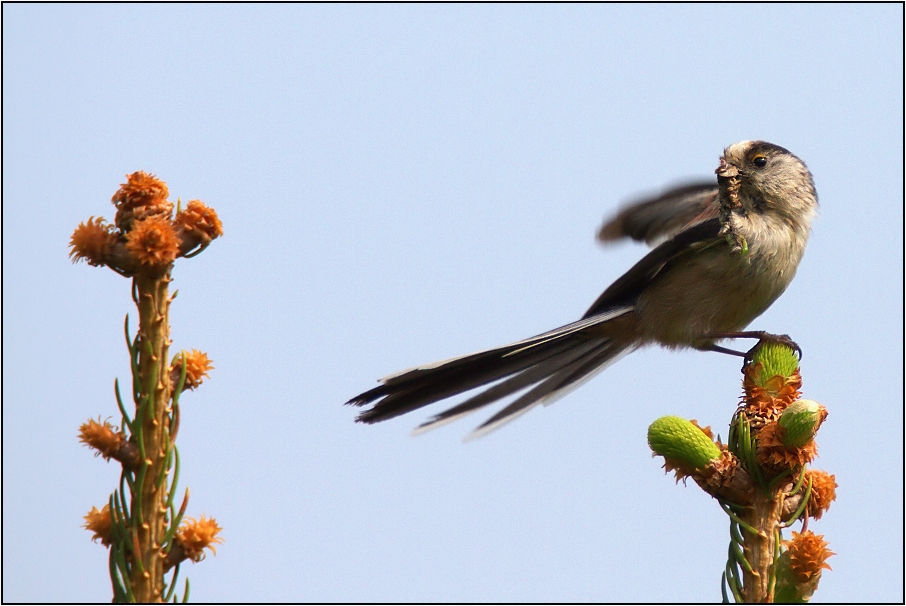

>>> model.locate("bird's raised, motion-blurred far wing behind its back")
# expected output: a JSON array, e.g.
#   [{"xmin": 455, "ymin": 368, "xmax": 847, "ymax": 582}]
[{"xmin": 598, "ymin": 181, "xmax": 719, "ymax": 245}]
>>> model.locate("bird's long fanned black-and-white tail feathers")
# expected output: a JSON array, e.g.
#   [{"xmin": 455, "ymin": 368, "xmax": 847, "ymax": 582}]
[{"xmin": 347, "ymin": 307, "xmax": 634, "ymax": 437}]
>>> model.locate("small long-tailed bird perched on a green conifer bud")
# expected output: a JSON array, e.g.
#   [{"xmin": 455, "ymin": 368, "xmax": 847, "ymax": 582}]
[{"xmin": 347, "ymin": 141, "xmax": 818, "ymax": 438}]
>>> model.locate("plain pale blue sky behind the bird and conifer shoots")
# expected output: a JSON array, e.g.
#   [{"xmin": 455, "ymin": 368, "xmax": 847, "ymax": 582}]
[{"xmin": 3, "ymin": 4, "xmax": 903, "ymax": 602}]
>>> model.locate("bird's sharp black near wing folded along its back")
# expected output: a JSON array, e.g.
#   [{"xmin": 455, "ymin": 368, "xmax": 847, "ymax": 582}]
[{"xmin": 582, "ymin": 217, "xmax": 723, "ymax": 318}]
